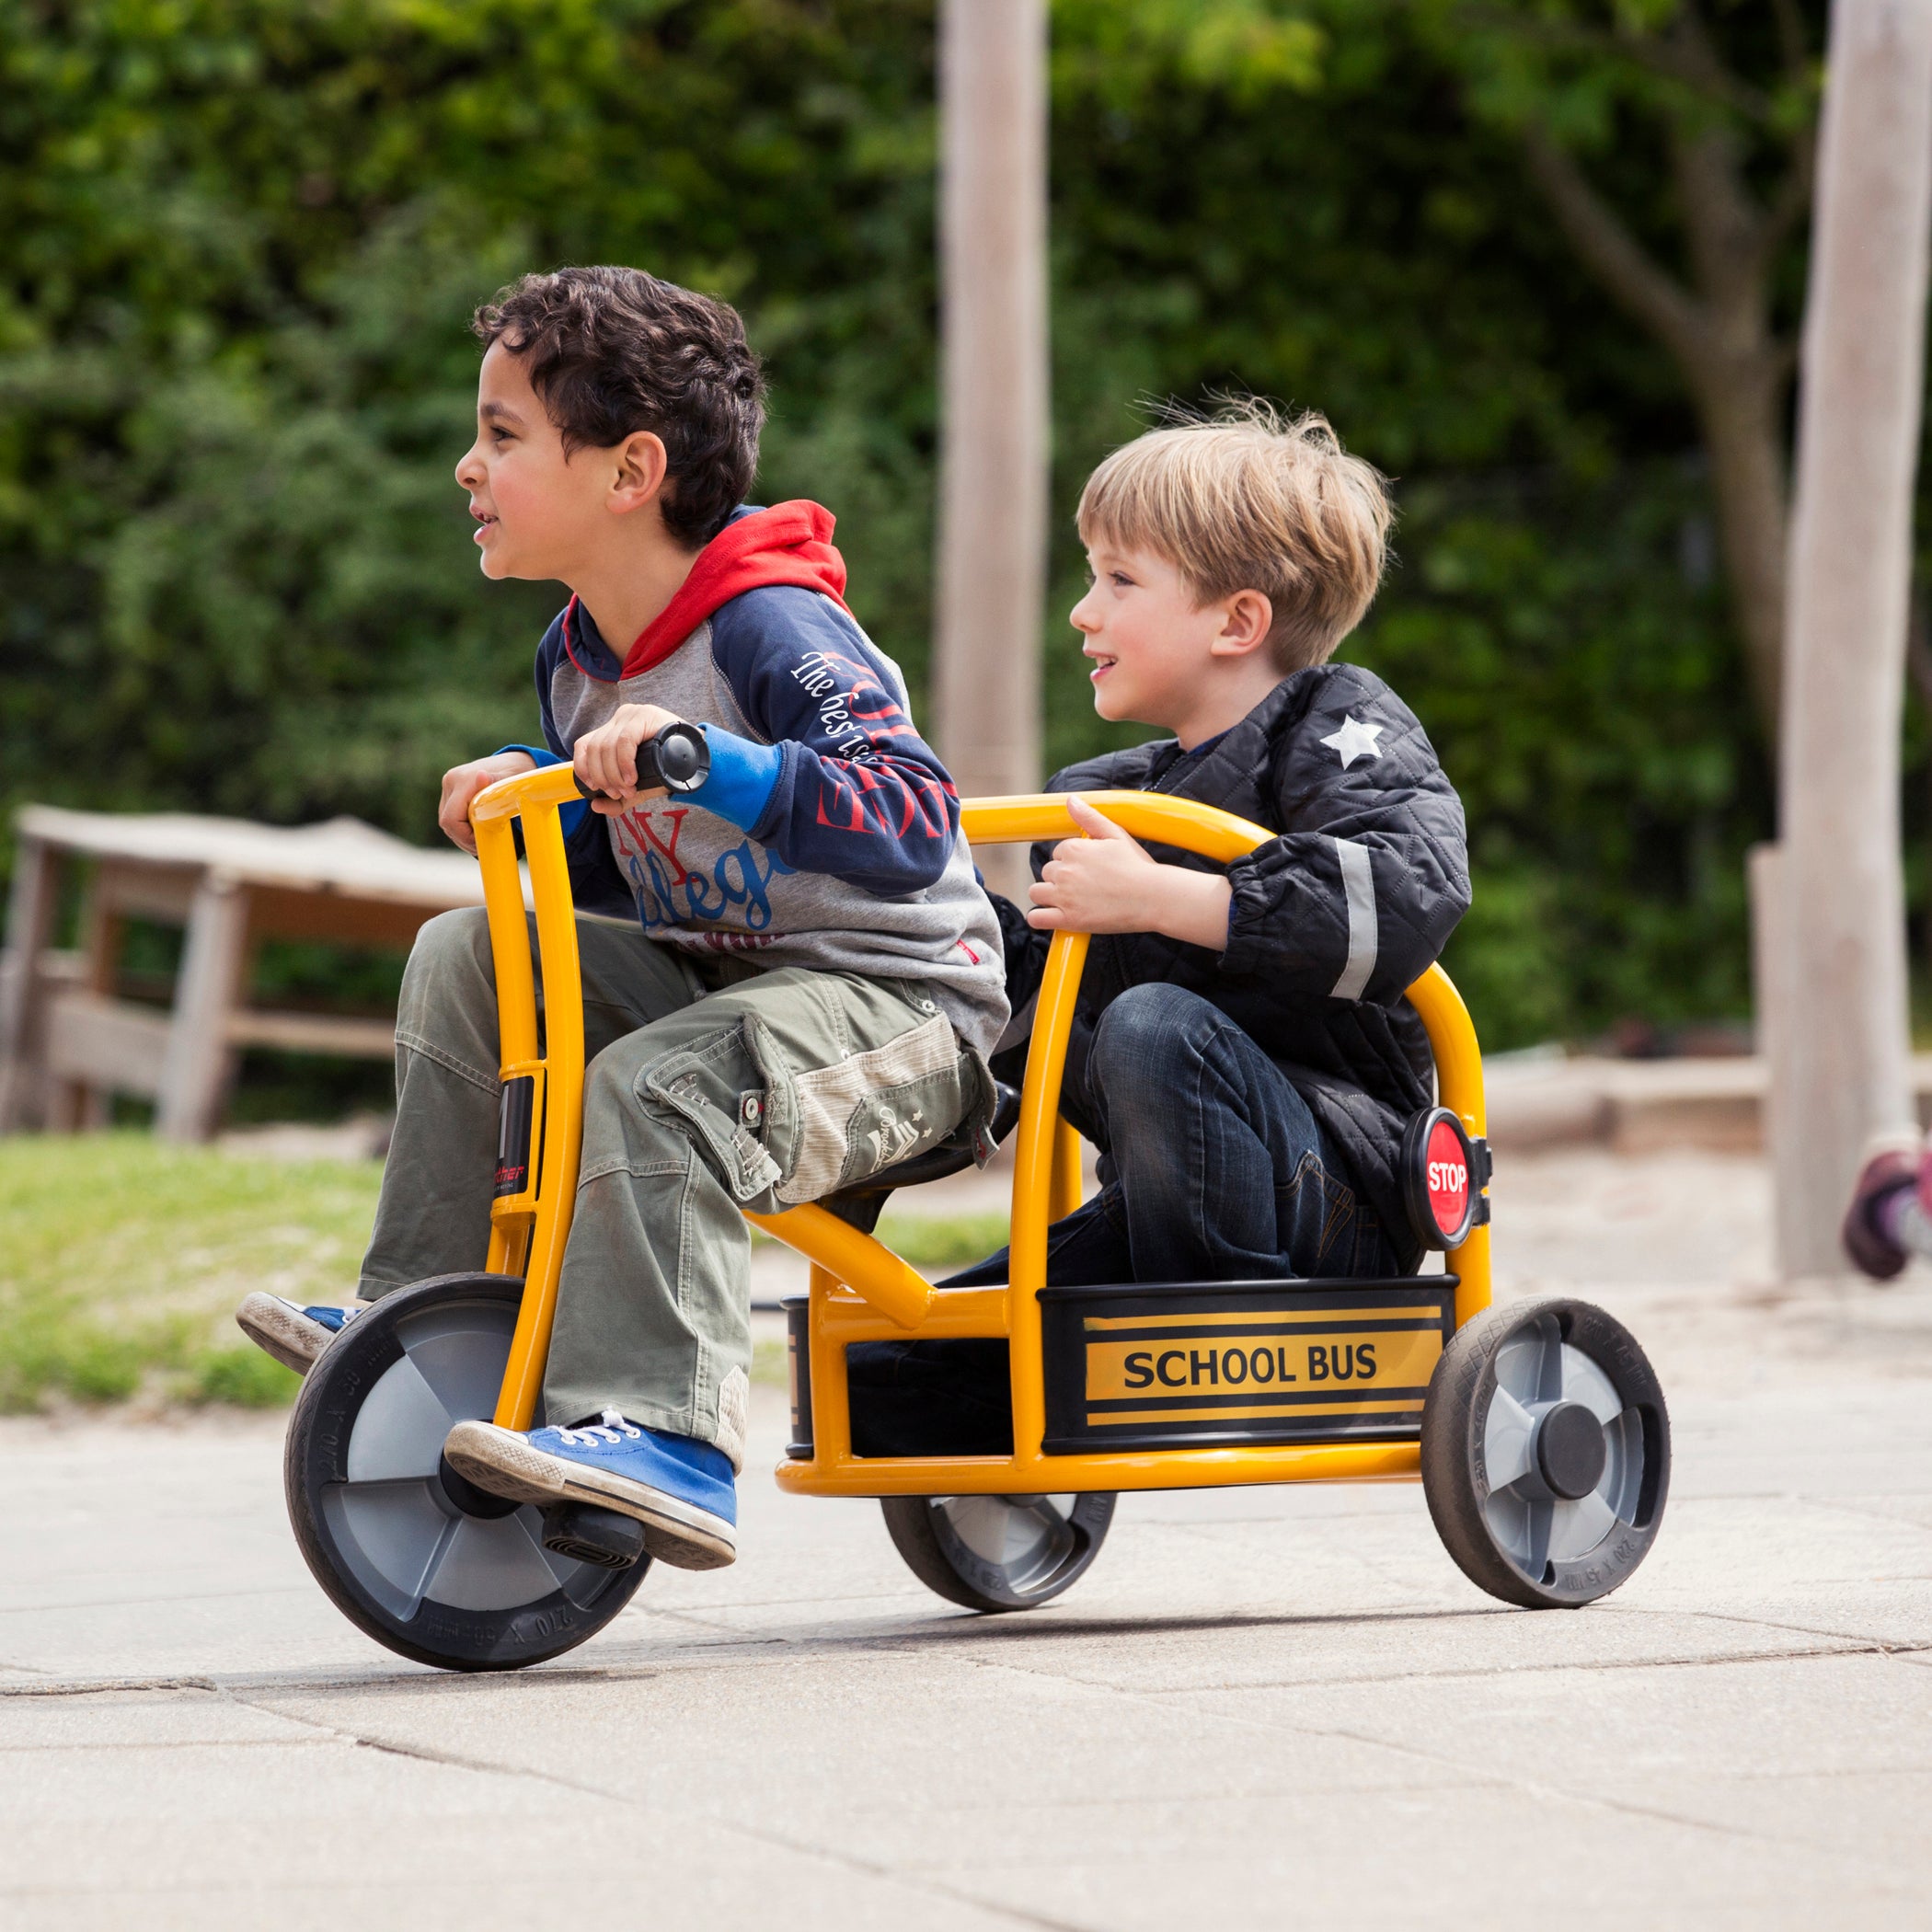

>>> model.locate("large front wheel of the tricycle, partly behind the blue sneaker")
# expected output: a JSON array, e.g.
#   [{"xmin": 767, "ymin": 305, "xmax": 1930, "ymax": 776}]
[{"xmin": 282, "ymin": 1275, "xmax": 650, "ymax": 1672}]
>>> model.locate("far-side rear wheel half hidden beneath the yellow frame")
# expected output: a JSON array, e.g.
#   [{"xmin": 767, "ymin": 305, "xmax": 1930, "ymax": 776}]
[{"xmin": 880, "ymin": 1493, "xmax": 1117, "ymax": 1611}]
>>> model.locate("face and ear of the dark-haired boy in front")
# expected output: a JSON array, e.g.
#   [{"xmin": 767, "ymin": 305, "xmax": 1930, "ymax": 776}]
[{"xmin": 456, "ymin": 342, "xmax": 662, "ymax": 585}]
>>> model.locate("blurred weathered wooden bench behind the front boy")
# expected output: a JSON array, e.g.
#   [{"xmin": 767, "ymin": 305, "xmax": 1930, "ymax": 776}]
[{"xmin": 0, "ymin": 806, "xmax": 506, "ymax": 1140}]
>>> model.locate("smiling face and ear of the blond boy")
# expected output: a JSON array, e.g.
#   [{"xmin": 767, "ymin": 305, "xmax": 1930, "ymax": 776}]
[{"xmin": 1070, "ymin": 539, "xmax": 1268, "ymax": 729}]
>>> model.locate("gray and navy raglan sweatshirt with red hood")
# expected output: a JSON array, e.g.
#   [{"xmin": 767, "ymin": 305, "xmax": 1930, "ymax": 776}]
[{"xmin": 520, "ymin": 502, "xmax": 1006, "ymax": 1059}]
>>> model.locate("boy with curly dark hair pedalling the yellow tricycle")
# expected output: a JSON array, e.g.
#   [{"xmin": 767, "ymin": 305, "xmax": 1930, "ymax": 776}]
[{"xmin": 239, "ymin": 269, "xmax": 1006, "ymax": 1569}]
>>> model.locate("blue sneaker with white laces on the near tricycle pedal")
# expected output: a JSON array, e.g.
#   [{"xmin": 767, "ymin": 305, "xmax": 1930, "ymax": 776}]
[{"xmin": 443, "ymin": 1409, "xmax": 738, "ymax": 1569}]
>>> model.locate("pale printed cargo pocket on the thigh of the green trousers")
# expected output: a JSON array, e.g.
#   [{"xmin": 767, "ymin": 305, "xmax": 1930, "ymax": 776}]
[{"xmin": 752, "ymin": 1012, "xmax": 972, "ymax": 1205}]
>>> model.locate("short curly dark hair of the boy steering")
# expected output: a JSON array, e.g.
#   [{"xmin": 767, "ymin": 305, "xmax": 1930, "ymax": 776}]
[{"xmin": 469, "ymin": 269, "xmax": 765, "ymax": 548}]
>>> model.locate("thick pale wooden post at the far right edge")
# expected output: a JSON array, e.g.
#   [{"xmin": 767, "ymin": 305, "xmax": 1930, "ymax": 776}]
[{"xmin": 1770, "ymin": 0, "xmax": 1932, "ymax": 1279}]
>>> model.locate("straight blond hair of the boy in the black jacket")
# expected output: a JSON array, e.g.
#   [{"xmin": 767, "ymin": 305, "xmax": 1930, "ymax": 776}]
[{"xmin": 1078, "ymin": 398, "xmax": 1395, "ymax": 676}]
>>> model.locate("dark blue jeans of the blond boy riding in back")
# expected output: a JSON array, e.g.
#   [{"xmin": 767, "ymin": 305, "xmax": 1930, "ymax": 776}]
[{"xmin": 949, "ymin": 983, "xmax": 1409, "ymax": 1287}]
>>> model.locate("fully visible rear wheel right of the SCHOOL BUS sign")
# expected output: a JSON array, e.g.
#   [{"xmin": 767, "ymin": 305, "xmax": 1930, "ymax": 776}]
[{"xmin": 1422, "ymin": 1296, "xmax": 1672, "ymax": 1609}]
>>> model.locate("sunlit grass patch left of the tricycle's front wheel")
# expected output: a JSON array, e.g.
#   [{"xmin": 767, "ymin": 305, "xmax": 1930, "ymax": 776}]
[{"xmin": 0, "ymin": 1133, "xmax": 381, "ymax": 1412}]
